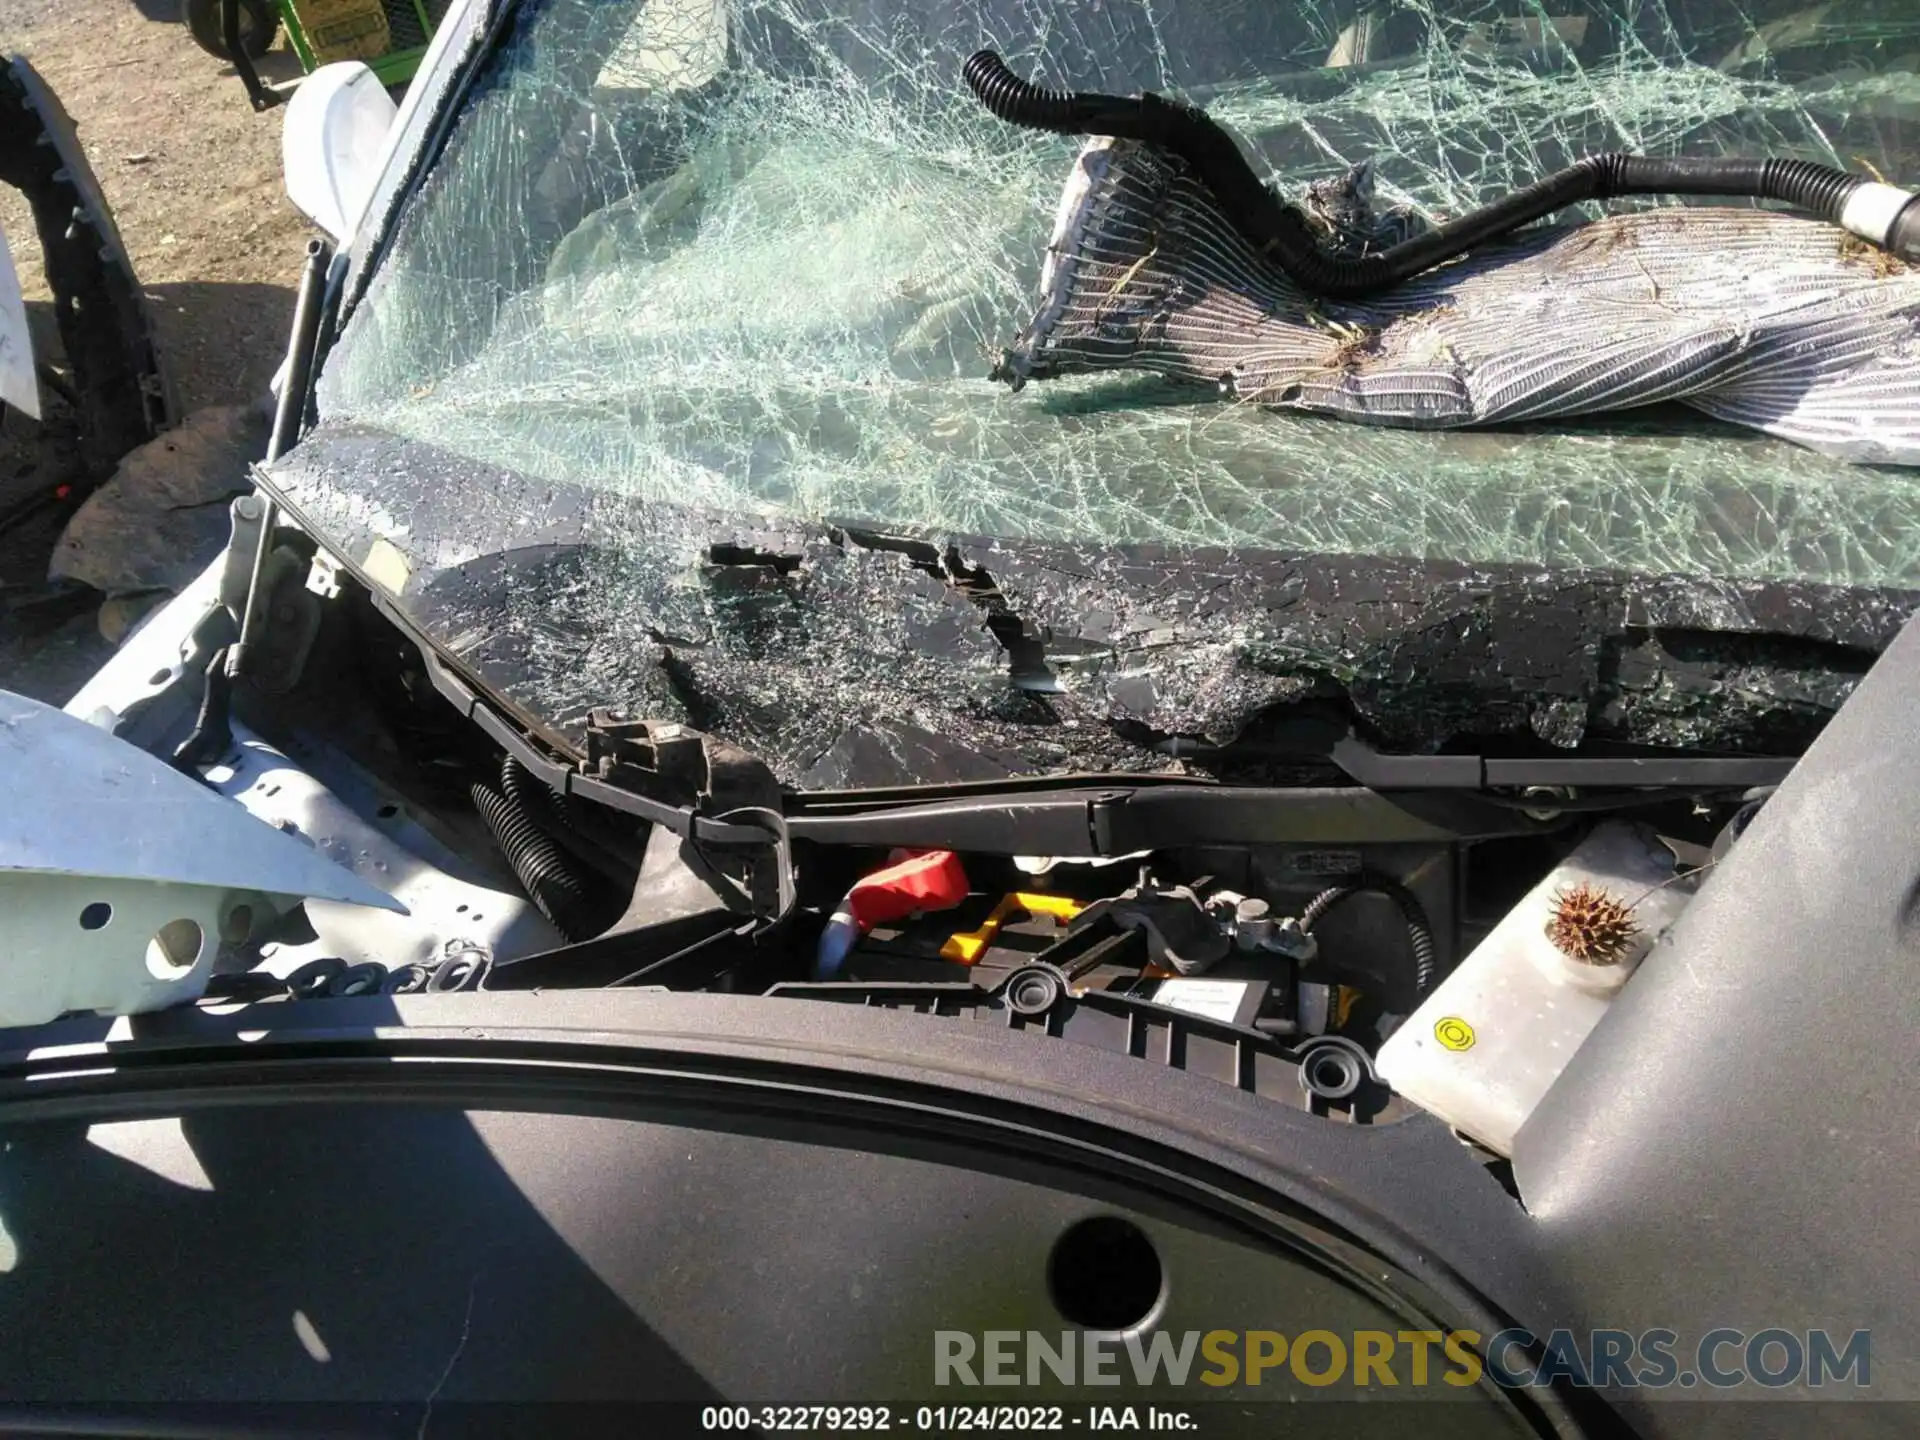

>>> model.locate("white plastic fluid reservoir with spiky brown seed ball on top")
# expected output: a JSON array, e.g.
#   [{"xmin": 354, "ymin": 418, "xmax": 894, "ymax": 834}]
[{"xmin": 1377, "ymin": 822, "xmax": 1693, "ymax": 1156}]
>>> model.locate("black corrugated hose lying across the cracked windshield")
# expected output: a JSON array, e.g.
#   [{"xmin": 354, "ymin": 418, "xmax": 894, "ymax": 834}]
[{"xmin": 962, "ymin": 50, "xmax": 1920, "ymax": 300}]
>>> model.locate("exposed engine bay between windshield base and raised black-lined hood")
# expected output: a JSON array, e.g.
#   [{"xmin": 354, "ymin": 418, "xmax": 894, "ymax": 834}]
[{"xmin": 41, "ymin": 545, "xmax": 1768, "ymax": 1171}]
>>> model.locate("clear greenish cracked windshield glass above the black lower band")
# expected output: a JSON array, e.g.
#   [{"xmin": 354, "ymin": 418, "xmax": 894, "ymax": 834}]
[{"xmin": 319, "ymin": 0, "xmax": 1920, "ymax": 584}]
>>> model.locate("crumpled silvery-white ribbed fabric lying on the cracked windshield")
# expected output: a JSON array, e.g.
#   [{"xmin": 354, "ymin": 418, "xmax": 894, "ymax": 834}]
[{"xmin": 1000, "ymin": 138, "xmax": 1920, "ymax": 465}]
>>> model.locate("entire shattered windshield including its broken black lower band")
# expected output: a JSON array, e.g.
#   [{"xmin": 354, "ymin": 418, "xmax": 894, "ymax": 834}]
[{"xmin": 273, "ymin": 0, "xmax": 1920, "ymax": 791}]
